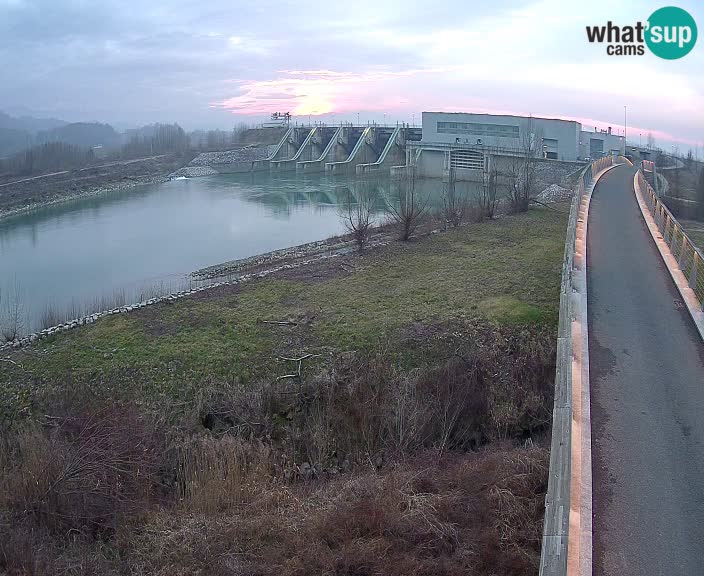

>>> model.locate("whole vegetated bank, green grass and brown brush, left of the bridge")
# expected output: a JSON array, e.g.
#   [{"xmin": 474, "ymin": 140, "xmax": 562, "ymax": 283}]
[{"xmin": 0, "ymin": 206, "xmax": 567, "ymax": 575}]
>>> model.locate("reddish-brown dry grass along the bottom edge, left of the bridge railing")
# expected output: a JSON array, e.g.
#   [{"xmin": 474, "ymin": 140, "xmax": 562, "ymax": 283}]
[{"xmin": 131, "ymin": 447, "xmax": 547, "ymax": 576}]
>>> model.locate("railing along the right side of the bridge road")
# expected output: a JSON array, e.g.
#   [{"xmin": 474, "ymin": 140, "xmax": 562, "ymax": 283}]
[{"xmin": 637, "ymin": 169, "xmax": 704, "ymax": 309}]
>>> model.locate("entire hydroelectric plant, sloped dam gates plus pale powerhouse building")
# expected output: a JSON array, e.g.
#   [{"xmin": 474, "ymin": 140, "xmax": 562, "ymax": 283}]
[{"xmin": 186, "ymin": 112, "xmax": 623, "ymax": 181}]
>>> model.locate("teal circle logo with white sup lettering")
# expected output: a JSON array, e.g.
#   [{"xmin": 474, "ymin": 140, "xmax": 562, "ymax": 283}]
[{"xmin": 645, "ymin": 6, "xmax": 697, "ymax": 60}]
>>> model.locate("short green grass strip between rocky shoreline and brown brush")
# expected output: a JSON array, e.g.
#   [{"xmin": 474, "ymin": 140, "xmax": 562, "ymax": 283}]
[{"xmin": 0, "ymin": 209, "xmax": 567, "ymax": 418}]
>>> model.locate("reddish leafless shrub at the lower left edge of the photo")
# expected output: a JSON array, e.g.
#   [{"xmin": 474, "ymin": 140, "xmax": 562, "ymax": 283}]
[{"xmin": 0, "ymin": 406, "xmax": 164, "ymax": 533}]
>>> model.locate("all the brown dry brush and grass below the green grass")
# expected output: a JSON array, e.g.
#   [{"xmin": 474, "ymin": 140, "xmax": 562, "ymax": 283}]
[{"xmin": 0, "ymin": 328, "xmax": 554, "ymax": 576}]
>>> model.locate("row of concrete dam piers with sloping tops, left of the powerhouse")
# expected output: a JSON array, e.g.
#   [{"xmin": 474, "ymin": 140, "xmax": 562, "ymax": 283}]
[{"xmin": 251, "ymin": 125, "xmax": 422, "ymax": 174}]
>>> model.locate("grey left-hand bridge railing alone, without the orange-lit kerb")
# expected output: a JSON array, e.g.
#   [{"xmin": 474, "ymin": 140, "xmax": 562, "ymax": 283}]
[{"xmin": 540, "ymin": 156, "xmax": 624, "ymax": 576}]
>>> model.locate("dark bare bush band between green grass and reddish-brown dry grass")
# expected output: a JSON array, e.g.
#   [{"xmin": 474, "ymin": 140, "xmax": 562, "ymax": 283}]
[{"xmin": 202, "ymin": 328, "xmax": 555, "ymax": 477}]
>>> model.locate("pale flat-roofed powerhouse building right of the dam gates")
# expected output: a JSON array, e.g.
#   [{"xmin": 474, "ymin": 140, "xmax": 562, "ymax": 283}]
[{"xmin": 415, "ymin": 112, "xmax": 623, "ymax": 176}]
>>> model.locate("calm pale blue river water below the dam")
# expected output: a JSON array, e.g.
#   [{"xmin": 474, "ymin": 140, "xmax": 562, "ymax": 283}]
[{"xmin": 0, "ymin": 174, "xmax": 490, "ymax": 332}]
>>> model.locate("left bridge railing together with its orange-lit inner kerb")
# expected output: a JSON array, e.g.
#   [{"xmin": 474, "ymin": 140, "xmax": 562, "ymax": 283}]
[{"xmin": 540, "ymin": 156, "xmax": 626, "ymax": 576}]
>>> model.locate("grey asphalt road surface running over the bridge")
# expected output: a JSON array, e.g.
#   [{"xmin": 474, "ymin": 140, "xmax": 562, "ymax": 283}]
[{"xmin": 587, "ymin": 166, "xmax": 704, "ymax": 576}]
